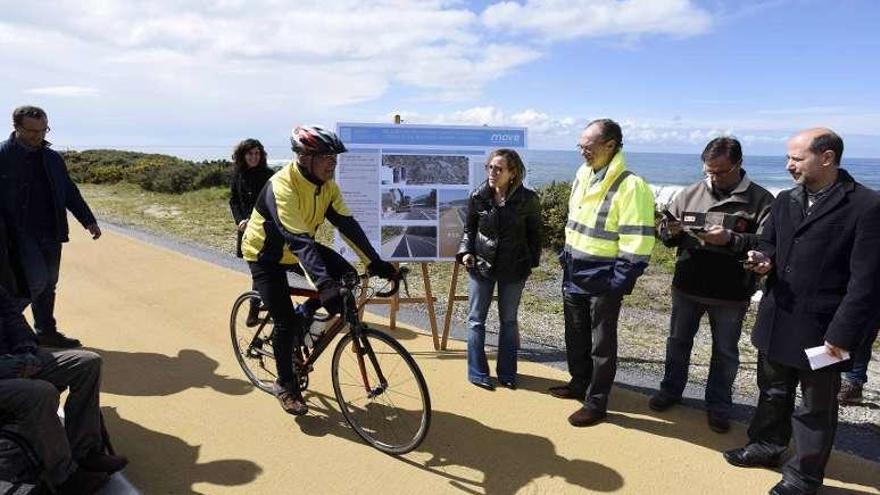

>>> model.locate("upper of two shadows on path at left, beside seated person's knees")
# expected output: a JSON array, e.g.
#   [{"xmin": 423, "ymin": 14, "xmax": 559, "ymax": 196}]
[{"xmin": 89, "ymin": 349, "xmax": 253, "ymax": 397}]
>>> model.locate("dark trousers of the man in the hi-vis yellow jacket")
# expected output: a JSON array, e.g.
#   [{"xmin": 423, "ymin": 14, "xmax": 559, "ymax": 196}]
[{"xmin": 563, "ymin": 294, "xmax": 623, "ymax": 412}]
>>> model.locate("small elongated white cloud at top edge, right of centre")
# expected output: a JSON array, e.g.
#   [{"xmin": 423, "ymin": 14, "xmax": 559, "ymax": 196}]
[{"xmin": 480, "ymin": 0, "xmax": 712, "ymax": 41}]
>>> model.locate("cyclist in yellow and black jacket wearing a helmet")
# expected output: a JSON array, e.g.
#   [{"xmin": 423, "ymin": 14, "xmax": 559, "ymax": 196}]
[{"xmin": 241, "ymin": 126, "xmax": 397, "ymax": 415}]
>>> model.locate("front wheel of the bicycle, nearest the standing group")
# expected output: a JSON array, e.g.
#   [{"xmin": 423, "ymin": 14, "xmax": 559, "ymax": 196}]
[{"xmin": 332, "ymin": 328, "xmax": 431, "ymax": 455}]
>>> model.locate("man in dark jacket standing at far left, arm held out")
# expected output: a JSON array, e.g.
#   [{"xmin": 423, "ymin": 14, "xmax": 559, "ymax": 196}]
[{"xmin": 0, "ymin": 106, "xmax": 101, "ymax": 348}]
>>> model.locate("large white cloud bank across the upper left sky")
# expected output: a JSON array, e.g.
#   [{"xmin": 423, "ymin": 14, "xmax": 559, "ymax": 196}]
[{"xmin": 0, "ymin": 0, "xmax": 524, "ymax": 108}]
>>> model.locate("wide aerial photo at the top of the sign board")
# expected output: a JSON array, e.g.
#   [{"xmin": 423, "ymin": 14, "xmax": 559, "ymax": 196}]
[{"xmin": 381, "ymin": 155, "xmax": 469, "ymax": 186}]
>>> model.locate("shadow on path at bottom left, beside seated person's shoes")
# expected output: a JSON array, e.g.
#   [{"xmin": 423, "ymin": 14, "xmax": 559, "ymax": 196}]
[{"xmin": 101, "ymin": 407, "xmax": 263, "ymax": 495}]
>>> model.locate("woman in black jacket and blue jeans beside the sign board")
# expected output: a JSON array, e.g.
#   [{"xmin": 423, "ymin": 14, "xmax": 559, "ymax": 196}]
[{"xmin": 456, "ymin": 149, "xmax": 541, "ymax": 390}]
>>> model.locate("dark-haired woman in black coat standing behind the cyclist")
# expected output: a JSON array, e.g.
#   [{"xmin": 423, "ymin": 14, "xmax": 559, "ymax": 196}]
[{"xmin": 229, "ymin": 139, "xmax": 274, "ymax": 326}]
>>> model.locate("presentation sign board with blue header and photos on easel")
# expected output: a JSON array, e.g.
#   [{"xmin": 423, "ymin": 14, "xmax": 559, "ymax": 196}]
[{"xmin": 336, "ymin": 123, "xmax": 527, "ymax": 261}]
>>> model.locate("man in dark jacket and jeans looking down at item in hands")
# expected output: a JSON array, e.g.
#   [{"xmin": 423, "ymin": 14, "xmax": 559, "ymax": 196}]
[{"xmin": 648, "ymin": 137, "xmax": 773, "ymax": 433}]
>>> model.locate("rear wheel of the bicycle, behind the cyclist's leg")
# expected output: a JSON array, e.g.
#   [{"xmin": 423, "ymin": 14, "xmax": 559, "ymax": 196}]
[{"xmin": 229, "ymin": 291, "xmax": 276, "ymax": 394}]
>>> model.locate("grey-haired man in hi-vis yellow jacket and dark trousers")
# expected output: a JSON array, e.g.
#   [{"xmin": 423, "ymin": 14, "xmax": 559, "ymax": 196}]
[{"xmin": 550, "ymin": 119, "xmax": 654, "ymax": 426}]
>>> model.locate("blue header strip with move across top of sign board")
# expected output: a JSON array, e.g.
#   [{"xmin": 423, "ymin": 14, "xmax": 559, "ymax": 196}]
[{"xmin": 339, "ymin": 124, "xmax": 526, "ymax": 148}]
